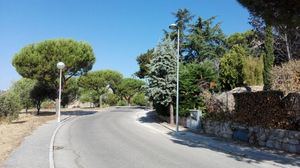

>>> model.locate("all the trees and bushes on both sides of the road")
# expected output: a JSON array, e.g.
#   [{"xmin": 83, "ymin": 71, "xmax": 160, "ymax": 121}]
[{"xmin": 0, "ymin": 0, "xmax": 300, "ymax": 134}]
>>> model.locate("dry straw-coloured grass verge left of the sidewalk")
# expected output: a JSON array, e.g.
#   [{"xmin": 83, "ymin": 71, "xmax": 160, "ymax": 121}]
[{"xmin": 0, "ymin": 112, "xmax": 55, "ymax": 167}]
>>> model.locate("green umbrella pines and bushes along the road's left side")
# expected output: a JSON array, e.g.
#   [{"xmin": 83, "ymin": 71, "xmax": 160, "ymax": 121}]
[{"xmin": 0, "ymin": 39, "xmax": 148, "ymax": 122}]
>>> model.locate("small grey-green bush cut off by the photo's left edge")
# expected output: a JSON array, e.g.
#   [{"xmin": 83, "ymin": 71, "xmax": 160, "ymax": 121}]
[{"xmin": 0, "ymin": 91, "xmax": 21, "ymax": 121}]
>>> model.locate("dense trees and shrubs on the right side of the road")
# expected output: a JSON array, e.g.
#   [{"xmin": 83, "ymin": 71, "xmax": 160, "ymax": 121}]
[{"xmin": 135, "ymin": 0, "xmax": 300, "ymax": 126}]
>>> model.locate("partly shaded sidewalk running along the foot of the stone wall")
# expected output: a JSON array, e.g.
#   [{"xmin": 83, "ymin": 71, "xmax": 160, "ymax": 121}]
[{"xmin": 137, "ymin": 111, "xmax": 300, "ymax": 167}]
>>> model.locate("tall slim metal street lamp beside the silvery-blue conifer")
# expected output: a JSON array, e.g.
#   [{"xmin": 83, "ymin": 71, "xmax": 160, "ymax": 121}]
[{"xmin": 169, "ymin": 23, "xmax": 180, "ymax": 132}]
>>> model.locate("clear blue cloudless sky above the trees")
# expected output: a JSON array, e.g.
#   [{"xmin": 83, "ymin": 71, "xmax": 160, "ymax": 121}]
[{"xmin": 0, "ymin": 0, "xmax": 250, "ymax": 89}]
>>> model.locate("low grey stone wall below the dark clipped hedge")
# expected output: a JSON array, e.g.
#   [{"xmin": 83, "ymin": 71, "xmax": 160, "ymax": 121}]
[{"xmin": 203, "ymin": 121, "xmax": 300, "ymax": 154}]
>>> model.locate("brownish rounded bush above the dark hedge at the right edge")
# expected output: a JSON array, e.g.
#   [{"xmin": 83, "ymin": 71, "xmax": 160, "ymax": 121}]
[{"xmin": 271, "ymin": 60, "xmax": 300, "ymax": 94}]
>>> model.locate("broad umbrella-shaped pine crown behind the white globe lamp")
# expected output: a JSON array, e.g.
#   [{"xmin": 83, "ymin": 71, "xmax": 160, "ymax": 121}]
[{"xmin": 13, "ymin": 39, "xmax": 95, "ymax": 87}]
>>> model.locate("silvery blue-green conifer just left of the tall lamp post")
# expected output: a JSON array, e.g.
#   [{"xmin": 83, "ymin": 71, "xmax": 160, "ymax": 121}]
[{"xmin": 148, "ymin": 38, "xmax": 176, "ymax": 124}]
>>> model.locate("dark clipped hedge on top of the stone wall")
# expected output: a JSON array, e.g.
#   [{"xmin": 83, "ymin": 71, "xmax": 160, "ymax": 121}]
[{"xmin": 233, "ymin": 91, "xmax": 300, "ymax": 130}]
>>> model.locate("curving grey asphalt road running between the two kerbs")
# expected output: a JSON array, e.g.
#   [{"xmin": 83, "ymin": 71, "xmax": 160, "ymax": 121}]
[{"xmin": 54, "ymin": 108, "xmax": 296, "ymax": 168}]
